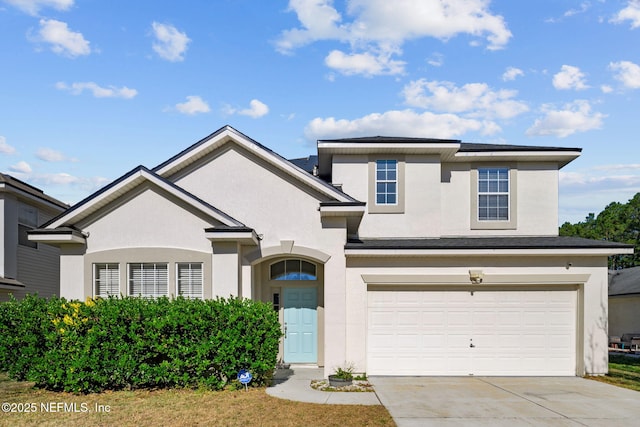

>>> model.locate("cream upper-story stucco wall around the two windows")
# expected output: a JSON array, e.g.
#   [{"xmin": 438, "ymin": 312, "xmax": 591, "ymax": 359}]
[{"xmin": 332, "ymin": 154, "xmax": 558, "ymax": 238}]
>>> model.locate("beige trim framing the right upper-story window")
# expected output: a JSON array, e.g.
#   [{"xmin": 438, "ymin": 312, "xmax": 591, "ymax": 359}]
[{"xmin": 470, "ymin": 164, "xmax": 518, "ymax": 230}]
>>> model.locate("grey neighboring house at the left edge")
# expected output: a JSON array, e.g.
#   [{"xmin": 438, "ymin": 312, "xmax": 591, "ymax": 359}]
[{"xmin": 0, "ymin": 173, "xmax": 69, "ymax": 301}]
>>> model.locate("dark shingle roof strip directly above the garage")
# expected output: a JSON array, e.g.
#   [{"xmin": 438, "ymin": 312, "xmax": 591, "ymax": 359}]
[{"xmin": 345, "ymin": 236, "xmax": 633, "ymax": 250}]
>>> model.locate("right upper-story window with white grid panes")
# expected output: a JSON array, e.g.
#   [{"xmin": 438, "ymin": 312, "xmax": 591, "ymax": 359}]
[{"xmin": 478, "ymin": 168, "xmax": 510, "ymax": 221}]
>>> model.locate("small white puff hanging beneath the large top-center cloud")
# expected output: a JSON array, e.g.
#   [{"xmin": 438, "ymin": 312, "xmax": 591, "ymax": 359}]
[{"xmin": 324, "ymin": 50, "xmax": 405, "ymax": 77}]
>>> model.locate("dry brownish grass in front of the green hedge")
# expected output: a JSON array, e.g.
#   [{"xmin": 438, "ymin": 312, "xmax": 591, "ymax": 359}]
[{"xmin": 0, "ymin": 374, "xmax": 395, "ymax": 426}]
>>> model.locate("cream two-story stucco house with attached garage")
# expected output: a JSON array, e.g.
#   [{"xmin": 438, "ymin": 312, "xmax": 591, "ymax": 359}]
[{"xmin": 30, "ymin": 126, "xmax": 633, "ymax": 375}]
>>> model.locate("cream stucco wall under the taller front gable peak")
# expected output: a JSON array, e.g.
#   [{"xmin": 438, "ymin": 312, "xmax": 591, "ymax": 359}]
[{"xmin": 176, "ymin": 143, "xmax": 338, "ymax": 249}]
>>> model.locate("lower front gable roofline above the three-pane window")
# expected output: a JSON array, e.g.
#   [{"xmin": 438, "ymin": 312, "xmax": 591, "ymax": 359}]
[{"xmin": 40, "ymin": 165, "xmax": 244, "ymax": 229}]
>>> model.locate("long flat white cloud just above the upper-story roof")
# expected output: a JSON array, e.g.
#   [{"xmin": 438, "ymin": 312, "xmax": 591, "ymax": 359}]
[{"xmin": 305, "ymin": 110, "xmax": 498, "ymax": 141}]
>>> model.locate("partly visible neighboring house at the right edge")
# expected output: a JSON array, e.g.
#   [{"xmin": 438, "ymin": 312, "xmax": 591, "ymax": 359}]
[{"xmin": 609, "ymin": 267, "xmax": 640, "ymax": 337}]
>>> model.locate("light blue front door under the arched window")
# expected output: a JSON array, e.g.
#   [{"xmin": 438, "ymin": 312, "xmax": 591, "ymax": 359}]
[{"xmin": 283, "ymin": 288, "xmax": 318, "ymax": 363}]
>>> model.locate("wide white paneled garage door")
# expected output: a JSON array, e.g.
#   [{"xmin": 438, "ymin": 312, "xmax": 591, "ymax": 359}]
[{"xmin": 367, "ymin": 290, "xmax": 577, "ymax": 376}]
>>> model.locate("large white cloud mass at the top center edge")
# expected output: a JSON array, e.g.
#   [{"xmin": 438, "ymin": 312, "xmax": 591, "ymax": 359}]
[{"xmin": 276, "ymin": 0, "xmax": 511, "ymax": 75}]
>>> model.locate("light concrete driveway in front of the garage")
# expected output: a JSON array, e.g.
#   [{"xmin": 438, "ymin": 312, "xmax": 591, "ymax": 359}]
[{"xmin": 369, "ymin": 377, "xmax": 640, "ymax": 427}]
